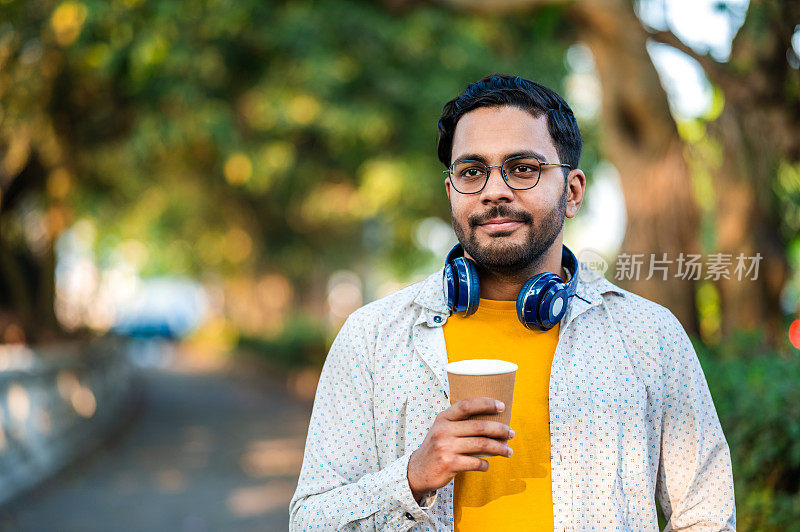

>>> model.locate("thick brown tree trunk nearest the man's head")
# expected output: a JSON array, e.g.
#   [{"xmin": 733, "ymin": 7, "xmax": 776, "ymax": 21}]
[{"xmin": 567, "ymin": 1, "xmax": 700, "ymax": 333}]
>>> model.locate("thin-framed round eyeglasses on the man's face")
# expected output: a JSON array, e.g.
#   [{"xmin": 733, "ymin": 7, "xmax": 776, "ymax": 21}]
[{"xmin": 442, "ymin": 155, "xmax": 572, "ymax": 194}]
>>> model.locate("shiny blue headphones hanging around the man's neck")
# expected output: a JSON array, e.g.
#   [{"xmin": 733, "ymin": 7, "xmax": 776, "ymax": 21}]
[{"xmin": 444, "ymin": 244, "xmax": 578, "ymax": 331}]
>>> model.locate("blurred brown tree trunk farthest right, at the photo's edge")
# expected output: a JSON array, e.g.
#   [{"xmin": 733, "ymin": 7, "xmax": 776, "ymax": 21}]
[{"xmin": 654, "ymin": 0, "xmax": 800, "ymax": 344}]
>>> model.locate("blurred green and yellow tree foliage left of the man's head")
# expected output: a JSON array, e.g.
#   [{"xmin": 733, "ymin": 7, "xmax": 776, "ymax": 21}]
[{"xmin": 0, "ymin": 0, "xmax": 580, "ymax": 286}]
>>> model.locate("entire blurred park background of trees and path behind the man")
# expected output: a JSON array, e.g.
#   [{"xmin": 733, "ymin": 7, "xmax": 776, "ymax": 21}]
[{"xmin": 0, "ymin": 0, "xmax": 800, "ymax": 531}]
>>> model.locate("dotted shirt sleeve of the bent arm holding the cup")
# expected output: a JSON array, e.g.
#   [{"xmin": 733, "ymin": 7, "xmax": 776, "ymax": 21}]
[{"xmin": 289, "ymin": 314, "xmax": 436, "ymax": 531}]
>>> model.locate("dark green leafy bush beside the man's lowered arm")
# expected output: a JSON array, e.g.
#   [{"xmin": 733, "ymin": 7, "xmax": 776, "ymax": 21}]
[{"xmin": 697, "ymin": 334, "xmax": 800, "ymax": 532}]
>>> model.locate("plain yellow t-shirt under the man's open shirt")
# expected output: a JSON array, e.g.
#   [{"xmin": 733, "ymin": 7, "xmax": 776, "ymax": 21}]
[{"xmin": 444, "ymin": 299, "xmax": 559, "ymax": 532}]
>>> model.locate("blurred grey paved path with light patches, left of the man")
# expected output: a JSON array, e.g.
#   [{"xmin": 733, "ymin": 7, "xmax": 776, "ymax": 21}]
[{"xmin": 0, "ymin": 350, "xmax": 311, "ymax": 532}]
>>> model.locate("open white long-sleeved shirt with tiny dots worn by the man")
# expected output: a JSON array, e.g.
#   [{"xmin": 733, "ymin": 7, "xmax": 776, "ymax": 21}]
[{"xmin": 289, "ymin": 263, "xmax": 736, "ymax": 532}]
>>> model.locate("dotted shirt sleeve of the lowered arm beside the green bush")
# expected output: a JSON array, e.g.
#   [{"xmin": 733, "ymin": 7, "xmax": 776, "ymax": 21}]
[{"xmin": 656, "ymin": 311, "xmax": 736, "ymax": 532}]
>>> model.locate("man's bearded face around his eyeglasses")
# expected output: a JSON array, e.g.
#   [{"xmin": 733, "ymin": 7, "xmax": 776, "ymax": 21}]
[{"xmin": 445, "ymin": 106, "xmax": 582, "ymax": 273}]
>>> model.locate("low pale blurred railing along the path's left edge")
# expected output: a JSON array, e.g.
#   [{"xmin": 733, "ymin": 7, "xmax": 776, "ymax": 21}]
[{"xmin": 0, "ymin": 338, "xmax": 135, "ymax": 505}]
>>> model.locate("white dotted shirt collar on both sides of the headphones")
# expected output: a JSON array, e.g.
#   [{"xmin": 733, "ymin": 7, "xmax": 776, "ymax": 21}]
[{"xmin": 414, "ymin": 261, "xmax": 625, "ymax": 328}]
